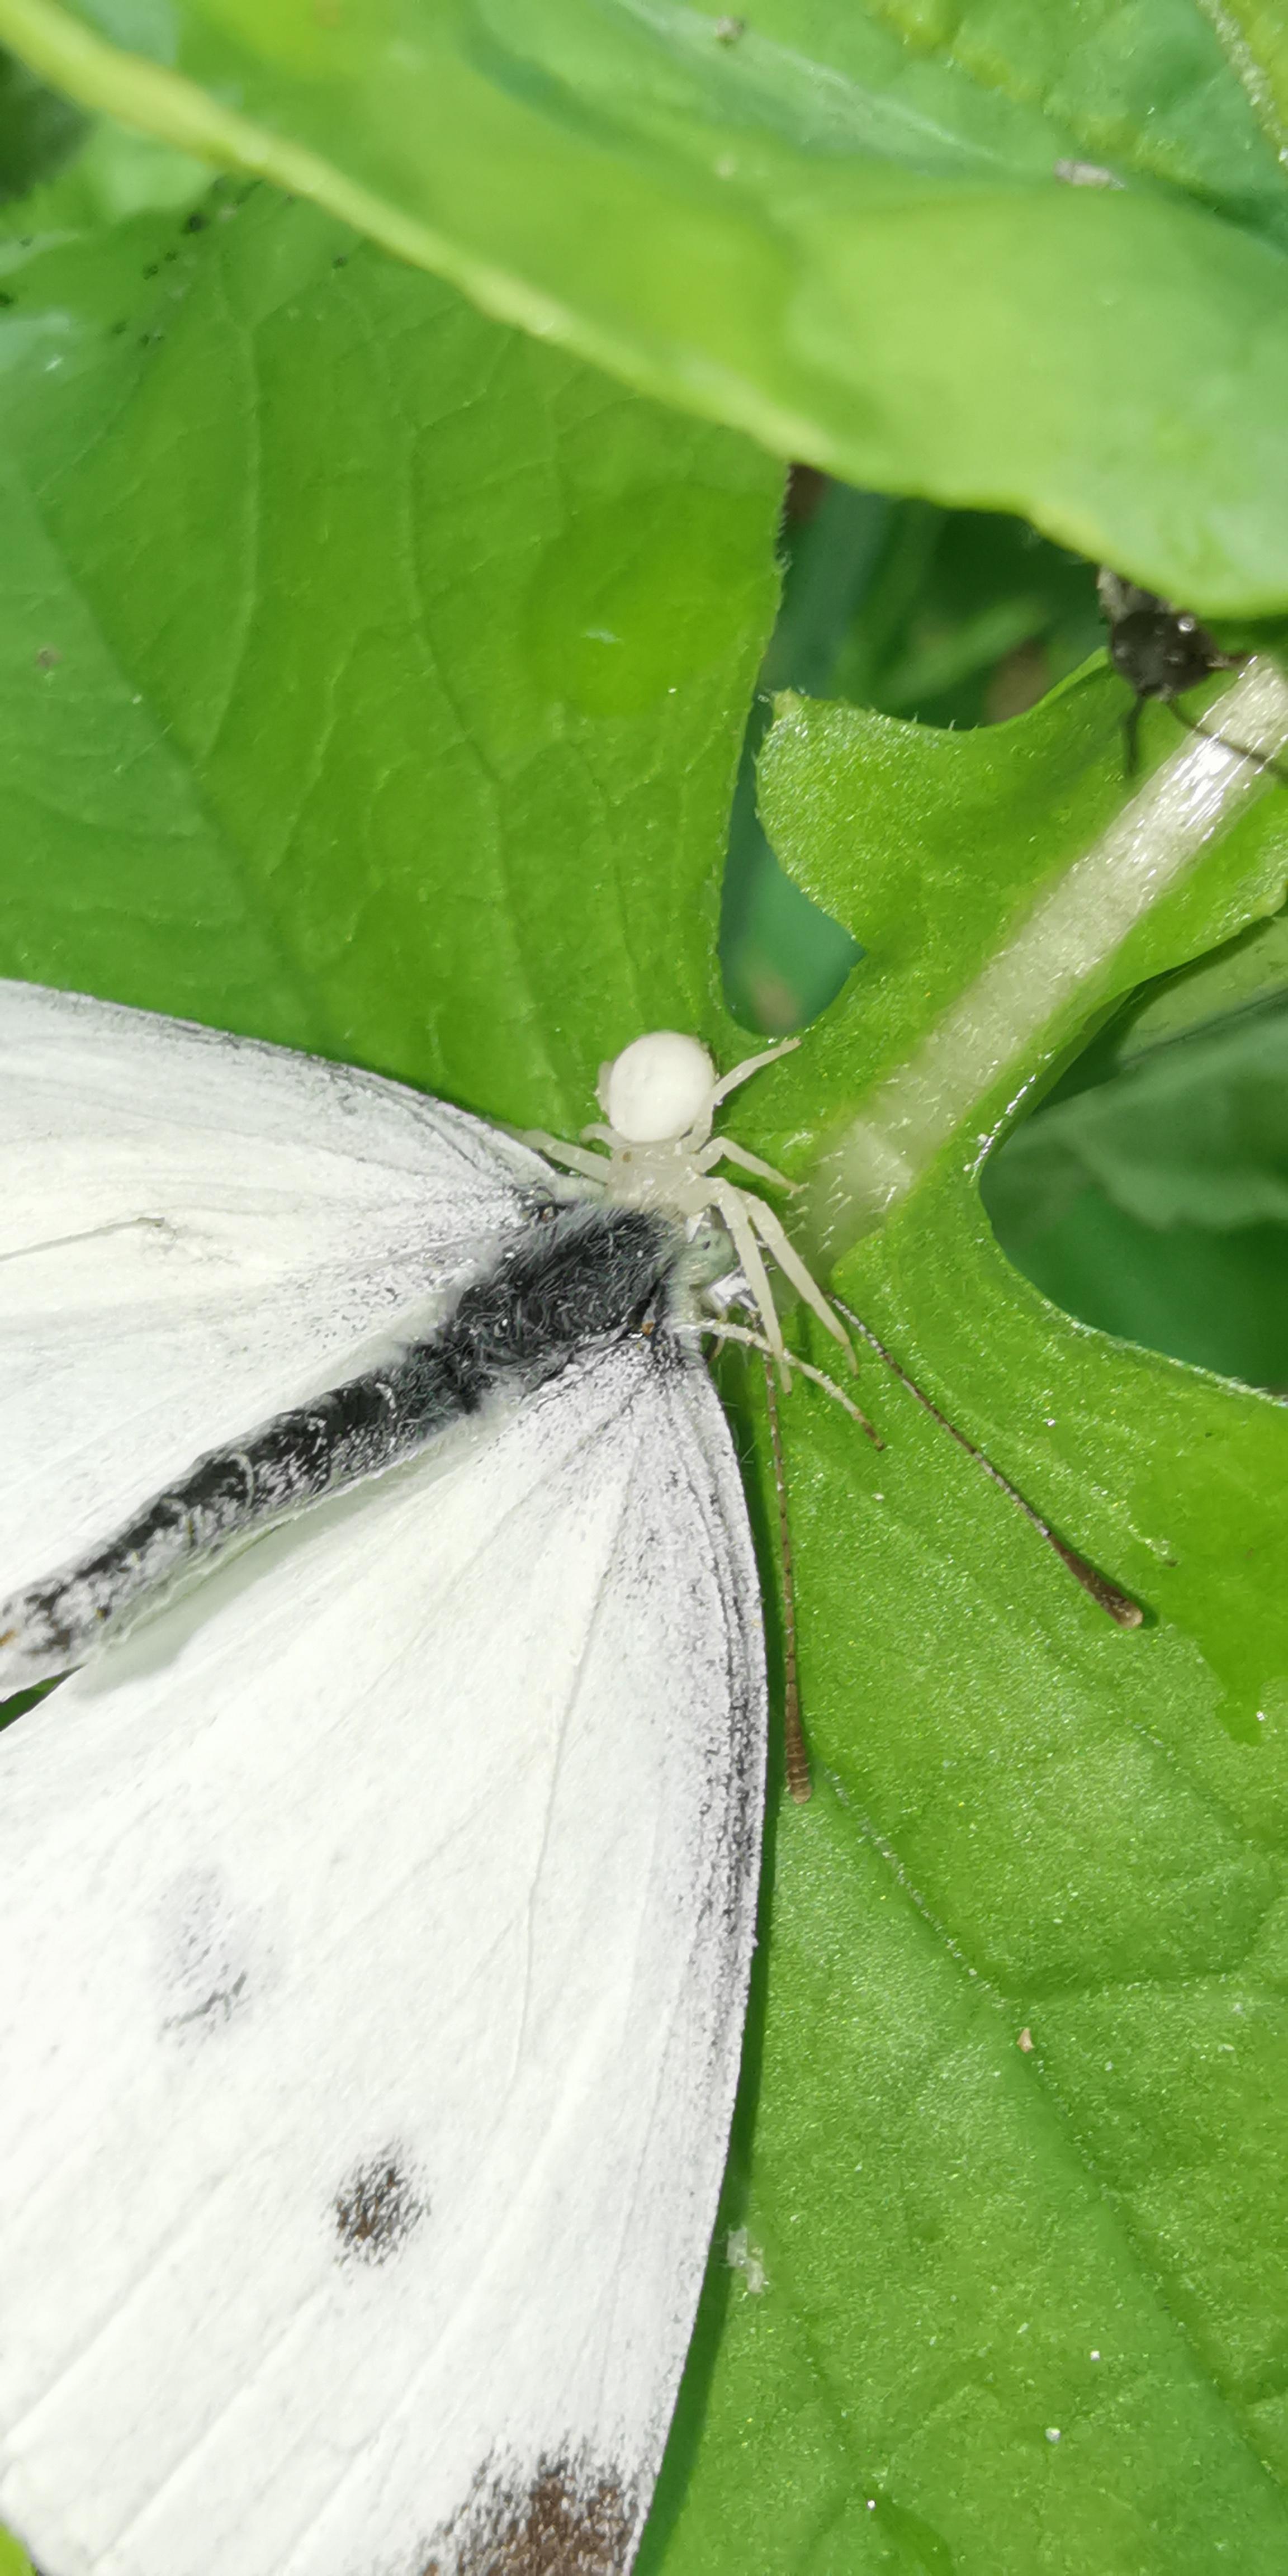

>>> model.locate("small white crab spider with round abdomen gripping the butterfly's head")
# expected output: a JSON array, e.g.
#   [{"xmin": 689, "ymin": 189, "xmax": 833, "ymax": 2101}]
[{"xmin": 525, "ymin": 1028, "xmax": 853, "ymax": 1370}]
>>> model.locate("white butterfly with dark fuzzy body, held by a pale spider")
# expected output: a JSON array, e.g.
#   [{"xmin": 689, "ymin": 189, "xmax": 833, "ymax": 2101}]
[{"xmin": 0, "ymin": 984, "xmax": 840, "ymax": 2576}]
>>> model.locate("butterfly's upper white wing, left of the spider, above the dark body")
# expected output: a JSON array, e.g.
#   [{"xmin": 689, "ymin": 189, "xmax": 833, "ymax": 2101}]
[{"xmin": 0, "ymin": 982, "xmax": 548, "ymax": 1592}]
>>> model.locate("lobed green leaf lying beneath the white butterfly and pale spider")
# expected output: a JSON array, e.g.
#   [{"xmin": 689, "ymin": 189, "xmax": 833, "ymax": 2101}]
[{"xmin": 0, "ymin": 166, "xmax": 1288, "ymax": 2576}]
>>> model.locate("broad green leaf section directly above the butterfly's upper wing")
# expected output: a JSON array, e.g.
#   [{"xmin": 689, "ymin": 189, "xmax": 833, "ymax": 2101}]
[{"xmin": 0, "ymin": 171, "xmax": 780, "ymax": 1128}]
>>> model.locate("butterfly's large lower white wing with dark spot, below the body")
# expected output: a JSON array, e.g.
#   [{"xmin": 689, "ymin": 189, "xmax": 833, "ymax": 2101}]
[{"xmin": 0, "ymin": 1344, "xmax": 763, "ymax": 2576}]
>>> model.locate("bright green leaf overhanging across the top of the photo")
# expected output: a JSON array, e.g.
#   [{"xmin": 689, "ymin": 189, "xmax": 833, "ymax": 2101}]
[{"xmin": 0, "ymin": 0, "xmax": 1288, "ymax": 613}]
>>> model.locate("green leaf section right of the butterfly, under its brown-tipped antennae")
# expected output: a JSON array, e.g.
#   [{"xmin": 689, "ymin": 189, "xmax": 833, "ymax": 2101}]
[{"xmin": 649, "ymin": 675, "xmax": 1288, "ymax": 2576}]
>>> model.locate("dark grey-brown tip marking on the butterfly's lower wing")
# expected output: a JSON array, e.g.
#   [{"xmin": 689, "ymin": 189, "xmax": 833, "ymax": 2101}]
[{"xmin": 415, "ymin": 2455, "xmax": 636, "ymax": 2576}]
